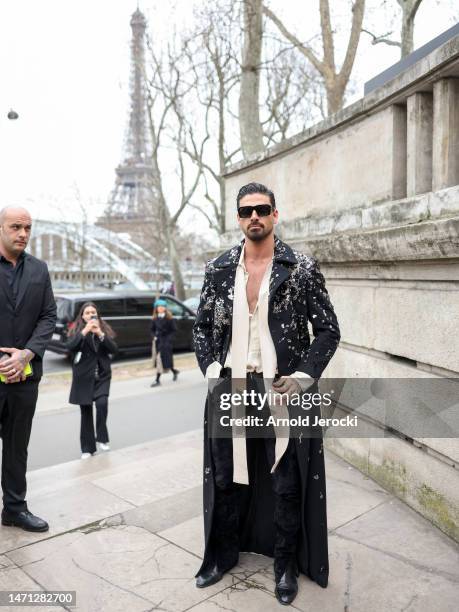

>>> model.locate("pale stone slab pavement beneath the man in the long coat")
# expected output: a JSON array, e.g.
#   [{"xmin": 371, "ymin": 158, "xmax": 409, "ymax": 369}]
[{"xmin": 0, "ymin": 431, "xmax": 459, "ymax": 612}]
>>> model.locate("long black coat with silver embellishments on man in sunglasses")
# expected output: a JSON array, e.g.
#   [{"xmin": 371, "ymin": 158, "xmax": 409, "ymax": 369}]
[{"xmin": 193, "ymin": 238, "xmax": 340, "ymax": 587}]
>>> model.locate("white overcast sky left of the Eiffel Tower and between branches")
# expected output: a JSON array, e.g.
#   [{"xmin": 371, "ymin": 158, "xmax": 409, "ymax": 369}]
[{"xmin": 0, "ymin": 0, "xmax": 458, "ymax": 227}]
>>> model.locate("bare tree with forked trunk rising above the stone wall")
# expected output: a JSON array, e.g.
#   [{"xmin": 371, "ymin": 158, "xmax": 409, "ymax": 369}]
[{"xmin": 263, "ymin": 0, "xmax": 365, "ymax": 114}]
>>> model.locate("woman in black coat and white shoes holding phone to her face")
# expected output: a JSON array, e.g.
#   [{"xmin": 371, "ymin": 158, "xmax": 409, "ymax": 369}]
[{"xmin": 67, "ymin": 302, "xmax": 118, "ymax": 459}]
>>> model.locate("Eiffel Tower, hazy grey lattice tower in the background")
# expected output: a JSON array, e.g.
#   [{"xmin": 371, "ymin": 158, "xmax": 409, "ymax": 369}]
[{"xmin": 97, "ymin": 8, "xmax": 155, "ymax": 244}]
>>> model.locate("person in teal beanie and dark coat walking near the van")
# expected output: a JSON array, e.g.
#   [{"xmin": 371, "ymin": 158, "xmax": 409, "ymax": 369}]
[{"xmin": 151, "ymin": 299, "xmax": 179, "ymax": 387}]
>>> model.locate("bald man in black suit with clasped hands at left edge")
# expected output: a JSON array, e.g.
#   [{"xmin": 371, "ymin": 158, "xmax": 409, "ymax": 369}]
[{"xmin": 0, "ymin": 207, "xmax": 56, "ymax": 531}]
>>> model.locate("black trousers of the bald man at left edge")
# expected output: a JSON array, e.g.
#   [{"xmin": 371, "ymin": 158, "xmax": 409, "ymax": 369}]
[{"xmin": 0, "ymin": 380, "xmax": 38, "ymax": 513}]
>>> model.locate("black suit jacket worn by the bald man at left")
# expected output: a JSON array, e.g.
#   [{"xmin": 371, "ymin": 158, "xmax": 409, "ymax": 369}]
[{"xmin": 0, "ymin": 253, "xmax": 56, "ymax": 380}]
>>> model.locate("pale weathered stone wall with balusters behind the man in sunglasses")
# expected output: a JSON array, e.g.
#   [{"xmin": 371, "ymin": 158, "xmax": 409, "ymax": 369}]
[{"xmin": 222, "ymin": 37, "xmax": 459, "ymax": 539}]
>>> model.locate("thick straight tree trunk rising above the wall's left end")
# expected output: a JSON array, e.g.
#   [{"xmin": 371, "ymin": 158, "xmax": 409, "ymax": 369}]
[{"xmin": 239, "ymin": 0, "xmax": 265, "ymax": 158}]
